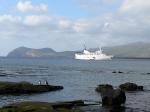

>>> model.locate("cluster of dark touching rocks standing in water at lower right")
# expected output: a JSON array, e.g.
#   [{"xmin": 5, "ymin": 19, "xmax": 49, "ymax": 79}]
[{"xmin": 95, "ymin": 82, "xmax": 144, "ymax": 107}]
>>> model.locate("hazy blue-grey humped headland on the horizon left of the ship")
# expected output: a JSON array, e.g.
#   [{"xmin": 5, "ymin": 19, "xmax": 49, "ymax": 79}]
[{"xmin": 7, "ymin": 47, "xmax": 56, "ymax": 58}]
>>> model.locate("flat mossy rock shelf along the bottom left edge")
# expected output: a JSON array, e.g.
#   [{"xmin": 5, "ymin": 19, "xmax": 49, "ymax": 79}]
[{"xmin": 0, "ymin": 100, "xmax": 84, "ymax": 112}]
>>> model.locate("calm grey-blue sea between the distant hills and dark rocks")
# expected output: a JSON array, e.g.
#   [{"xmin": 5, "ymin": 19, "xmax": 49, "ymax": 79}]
[{"xmin": 0, "ymin": 58, "xmax": 150, "ymax": 111}]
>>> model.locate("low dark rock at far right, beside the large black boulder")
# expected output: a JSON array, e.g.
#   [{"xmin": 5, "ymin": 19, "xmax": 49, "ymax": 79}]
[{"xmin": 119, "ymin": 82, "xmax": 143, "ymax": 91}]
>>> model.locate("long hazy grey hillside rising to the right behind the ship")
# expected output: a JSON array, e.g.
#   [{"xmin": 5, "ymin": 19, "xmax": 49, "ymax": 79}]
[{"xmin": 103, "ymin": 42, "xmax": 150, "ymax": 58}]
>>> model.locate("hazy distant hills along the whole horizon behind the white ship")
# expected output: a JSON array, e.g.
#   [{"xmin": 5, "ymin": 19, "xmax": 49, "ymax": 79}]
[{"xmin": 7, "ymin": 42, "xmax": 150, "ymax": 58}]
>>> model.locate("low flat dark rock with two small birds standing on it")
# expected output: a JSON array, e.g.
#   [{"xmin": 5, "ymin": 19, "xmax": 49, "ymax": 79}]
[{"xmin": 0, "ymin": 82, "xmax": 63, "ymax": 94}]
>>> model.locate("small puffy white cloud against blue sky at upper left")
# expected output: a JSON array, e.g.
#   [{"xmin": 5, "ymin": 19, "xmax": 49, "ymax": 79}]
[{"xmin": 17, "ymin": 1, "xmax": 48, "ymax": 12}]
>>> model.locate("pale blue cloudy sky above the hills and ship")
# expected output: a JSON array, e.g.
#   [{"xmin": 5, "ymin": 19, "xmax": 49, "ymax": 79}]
[{"xmin": 0, "ymin": 0, "xmax": 150, "ymax": 55}]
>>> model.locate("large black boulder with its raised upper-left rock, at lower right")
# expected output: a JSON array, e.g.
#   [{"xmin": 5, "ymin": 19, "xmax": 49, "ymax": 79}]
[{"xmin": 96, "ymin": 84, "xmax": 126, "ymax": 106}]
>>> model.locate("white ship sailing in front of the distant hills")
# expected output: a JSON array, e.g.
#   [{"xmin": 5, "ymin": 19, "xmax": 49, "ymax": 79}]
[{"xmin": 75, "ymin": 49, "xmax": 113, "ymax": 60}]
